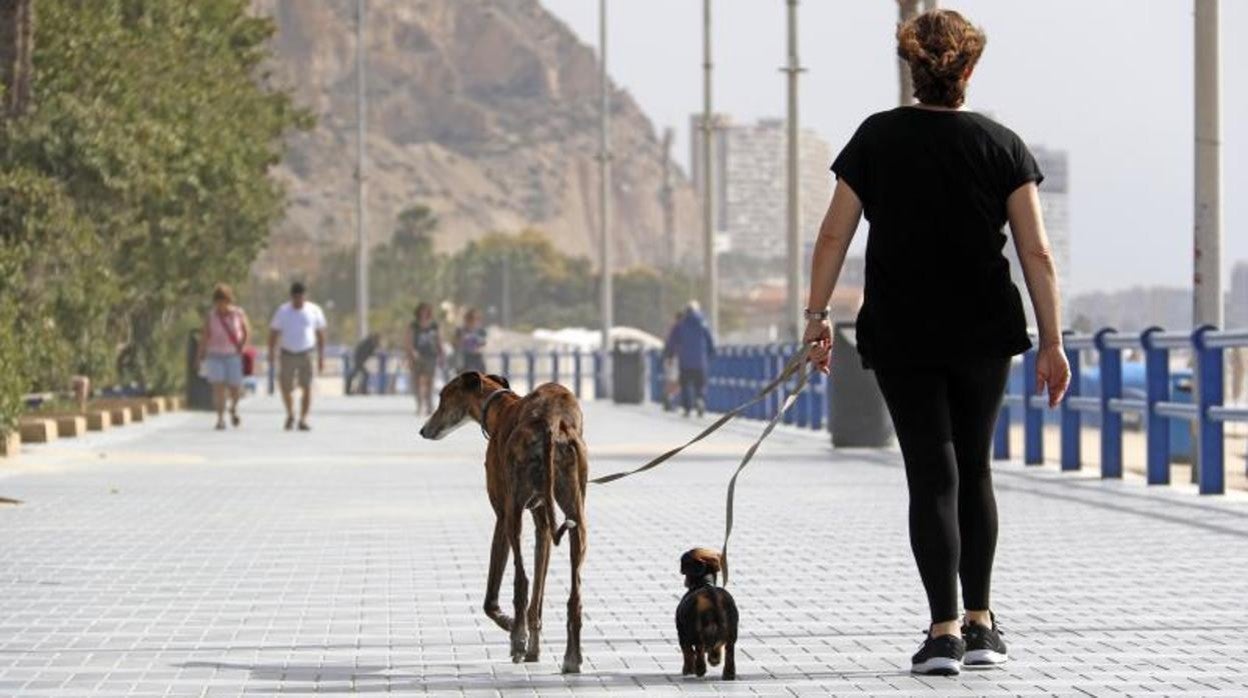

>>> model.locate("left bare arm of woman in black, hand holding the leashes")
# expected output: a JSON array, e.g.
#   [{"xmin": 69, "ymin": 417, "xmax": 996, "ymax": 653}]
[{"xmin": 802, "ymin": 180, "xmax": 862, "ymax": 372}]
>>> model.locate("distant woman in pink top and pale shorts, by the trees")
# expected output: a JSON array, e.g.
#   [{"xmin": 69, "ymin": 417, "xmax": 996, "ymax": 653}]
[{"xmin": 198, "ymin": 283, "xmax": 251, "ymax": 431}]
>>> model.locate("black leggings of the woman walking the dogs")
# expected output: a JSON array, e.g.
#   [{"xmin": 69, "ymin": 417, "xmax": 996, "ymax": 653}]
[{"xmin": 876, "ymin": 358, "xmax": 1010, "ymax": 623}]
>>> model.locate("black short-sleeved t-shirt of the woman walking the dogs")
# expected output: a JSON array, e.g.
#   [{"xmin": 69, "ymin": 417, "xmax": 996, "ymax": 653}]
[{"xmin": 832, "ymin": 107, "xmax": 1043, "ymax": 368}]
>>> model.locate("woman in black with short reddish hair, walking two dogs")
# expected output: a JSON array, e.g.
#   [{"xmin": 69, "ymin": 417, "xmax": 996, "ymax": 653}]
[{"xmin": 805, "ymin": 10, "xmax": 1070, "ymax": 674}]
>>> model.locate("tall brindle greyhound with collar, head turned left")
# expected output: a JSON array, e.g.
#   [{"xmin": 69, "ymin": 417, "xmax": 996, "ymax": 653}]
[{"xmin": 421, "ymin": 371, "xmax": 589, "ymax": 673}]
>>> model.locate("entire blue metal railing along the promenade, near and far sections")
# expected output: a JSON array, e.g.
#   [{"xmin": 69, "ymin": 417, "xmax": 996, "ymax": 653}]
[{"xmin": 331, "ymin": 327, "xmax": 1248, "ymax": 493}]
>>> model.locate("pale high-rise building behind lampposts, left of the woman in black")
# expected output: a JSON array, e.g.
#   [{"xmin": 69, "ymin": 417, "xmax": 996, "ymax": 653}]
[{"xmin": 690, "ymin": 115, "xmax": 832, "ymax": 260}]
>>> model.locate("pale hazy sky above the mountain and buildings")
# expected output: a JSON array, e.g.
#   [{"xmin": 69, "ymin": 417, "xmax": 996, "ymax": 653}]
[{"xmin": 542, "ymin": 0, "xmax": 1248, "ymax": 292}]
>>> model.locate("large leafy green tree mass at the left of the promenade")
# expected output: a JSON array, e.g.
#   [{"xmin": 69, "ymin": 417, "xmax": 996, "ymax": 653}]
[{"xmin": 0, "ymin": 0, "xmax": 308, "ymax": 432}]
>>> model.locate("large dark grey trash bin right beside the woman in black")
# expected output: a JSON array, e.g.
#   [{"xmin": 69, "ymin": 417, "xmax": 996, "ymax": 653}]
[{"xmin": 827, "ymin": 322, "xmax": 894, "ymax": 448}]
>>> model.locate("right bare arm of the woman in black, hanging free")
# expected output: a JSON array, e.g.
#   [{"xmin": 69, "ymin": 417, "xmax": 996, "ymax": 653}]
[{"xmin": 1006, "ymin": 182, "xmax": 1071, "ymax": 407}]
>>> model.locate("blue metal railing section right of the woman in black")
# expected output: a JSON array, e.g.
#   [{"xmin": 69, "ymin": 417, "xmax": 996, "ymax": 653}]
[{"xmin": 993, "ymin": 327, "xmax": 1248, "ymax": 494}]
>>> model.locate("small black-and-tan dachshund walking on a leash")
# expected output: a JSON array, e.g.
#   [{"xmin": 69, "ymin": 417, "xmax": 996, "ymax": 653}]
[{"xmin": 676, "ymin": 548, "xmax": 736, "ymax": 681}]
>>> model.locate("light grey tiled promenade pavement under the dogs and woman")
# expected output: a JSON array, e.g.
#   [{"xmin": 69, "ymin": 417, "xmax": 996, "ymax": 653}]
[{"xmin": 0, "ymin": 398, "xmax": 1248, "ymax": 697}]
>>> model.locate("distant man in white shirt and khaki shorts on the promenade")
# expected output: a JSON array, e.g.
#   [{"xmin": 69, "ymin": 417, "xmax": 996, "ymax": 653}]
[{"xmin": 268, "ymin": 281, "xmax": 324, "ymax": 431}]
